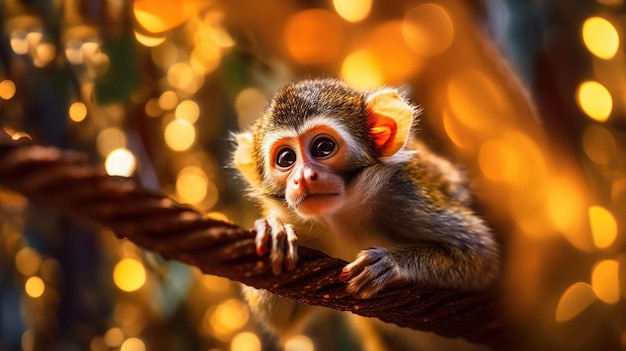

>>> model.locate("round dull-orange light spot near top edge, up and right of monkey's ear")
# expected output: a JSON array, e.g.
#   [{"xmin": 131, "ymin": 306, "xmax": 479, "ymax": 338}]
[{"xmin": 402, "ymin": 4, "xmax": 454, "ymax": 57}]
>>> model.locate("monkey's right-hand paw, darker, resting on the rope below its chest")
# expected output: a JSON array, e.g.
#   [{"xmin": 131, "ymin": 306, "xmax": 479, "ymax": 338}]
[{"xmin": 339, "ymin": 248, "xmax": 398, "ymax": 299}]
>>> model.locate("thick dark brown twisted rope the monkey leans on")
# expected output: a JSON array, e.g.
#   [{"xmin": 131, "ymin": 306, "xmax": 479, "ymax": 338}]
[{"xmin": 0, "ymin": 131, "xmax": 510, "ymax": 348}]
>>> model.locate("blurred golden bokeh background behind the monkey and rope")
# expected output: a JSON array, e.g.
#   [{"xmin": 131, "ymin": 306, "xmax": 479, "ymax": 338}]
[{"xmin": 0, "ymin": 0, "xmax": 626, "ymax": 351}]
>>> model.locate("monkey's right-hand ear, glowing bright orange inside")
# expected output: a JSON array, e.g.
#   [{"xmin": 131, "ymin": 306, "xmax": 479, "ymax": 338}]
[{"xmin": 366, "ymin": 90, "xmax": 414, "ymax": 157}]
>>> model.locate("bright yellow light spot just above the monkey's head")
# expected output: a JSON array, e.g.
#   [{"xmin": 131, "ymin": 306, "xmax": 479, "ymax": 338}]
[{"xmin": 341, "ymin": 49, "xmax": 384, "ymax": 88}]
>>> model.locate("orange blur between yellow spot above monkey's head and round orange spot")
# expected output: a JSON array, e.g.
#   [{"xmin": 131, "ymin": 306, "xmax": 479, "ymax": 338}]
[{"xmin": 367, "ymin": 21, "xmax": 422, "ymax": 84}]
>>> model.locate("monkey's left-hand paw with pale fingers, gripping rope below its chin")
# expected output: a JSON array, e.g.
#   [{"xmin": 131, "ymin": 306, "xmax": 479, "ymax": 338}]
[{"xmin": 254, "ymin": 215, "xmax": 298, "ymax": 275}]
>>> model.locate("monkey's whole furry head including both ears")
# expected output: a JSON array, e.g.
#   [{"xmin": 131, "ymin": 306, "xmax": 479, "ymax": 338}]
[{"xmin": 234, "ymin": 79, "xmax": 415, "ymax": 218}]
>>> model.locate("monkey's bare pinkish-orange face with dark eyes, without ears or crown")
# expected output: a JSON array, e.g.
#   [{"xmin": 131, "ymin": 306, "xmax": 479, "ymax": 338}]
[{"xmin": 266, "ymin": 119, "xmax": 350, "ymax": 218}]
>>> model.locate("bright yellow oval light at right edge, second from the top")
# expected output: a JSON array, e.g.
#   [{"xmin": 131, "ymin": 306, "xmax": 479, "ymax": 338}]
[{"xmin": 576, "ymin": 81, "xmax": 613, "ymax": 122}]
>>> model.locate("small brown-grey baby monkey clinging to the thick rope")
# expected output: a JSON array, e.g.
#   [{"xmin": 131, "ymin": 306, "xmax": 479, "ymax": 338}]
[{"xmin": 233, "ymin": 78, "xmax": 499, "ymax": 350}]
